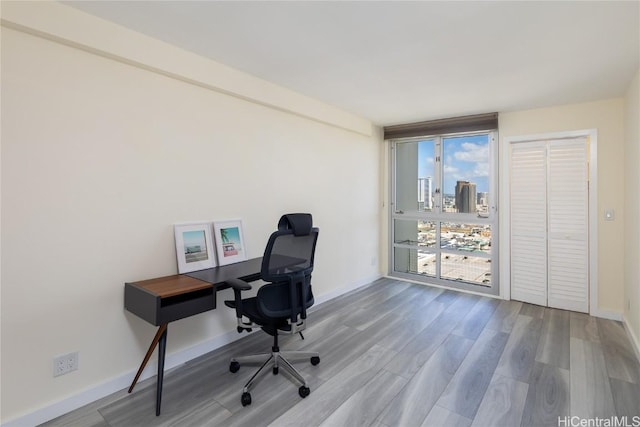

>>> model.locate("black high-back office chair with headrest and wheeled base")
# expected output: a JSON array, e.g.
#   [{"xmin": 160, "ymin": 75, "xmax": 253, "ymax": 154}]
[{"xmin": 224, "ymin": 214, "xmax": 320, "ymax": 406}]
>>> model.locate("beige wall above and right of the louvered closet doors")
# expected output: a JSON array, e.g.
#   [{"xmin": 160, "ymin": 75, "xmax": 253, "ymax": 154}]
[{"xmin": 500, "ymin": 98, "xmax": 625, "ymax": 314}]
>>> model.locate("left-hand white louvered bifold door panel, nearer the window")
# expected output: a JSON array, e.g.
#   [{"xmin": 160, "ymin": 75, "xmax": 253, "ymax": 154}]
[{"xmin": 510, "ymin": 142, "xmax": 547, "ymax": 306}]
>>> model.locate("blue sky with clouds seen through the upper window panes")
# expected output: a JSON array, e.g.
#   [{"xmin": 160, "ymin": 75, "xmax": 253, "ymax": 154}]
[{"xmin": 418, "ymin": 135, "xmax": 490, "ymax": 194}]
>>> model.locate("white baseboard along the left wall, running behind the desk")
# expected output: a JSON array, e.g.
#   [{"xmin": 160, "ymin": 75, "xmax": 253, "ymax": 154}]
[{"xmin": 2, "ymin": 275, "xmax": 380, "ymax": 427}]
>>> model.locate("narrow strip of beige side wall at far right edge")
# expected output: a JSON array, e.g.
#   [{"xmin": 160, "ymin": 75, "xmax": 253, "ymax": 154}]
[{"xmin": 623, "ymin": 70, "xmax": 640, "ymax": 351}]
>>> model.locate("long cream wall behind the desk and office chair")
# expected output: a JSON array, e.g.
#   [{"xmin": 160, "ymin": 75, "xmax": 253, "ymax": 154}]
[{"xmin": 1, "ymin": 3, "xmax": 382, "ymax": 422}]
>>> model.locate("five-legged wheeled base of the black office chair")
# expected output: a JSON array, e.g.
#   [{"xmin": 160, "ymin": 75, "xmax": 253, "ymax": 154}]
[{"xmin": 229, "ymin": 347, "xmax": 320, "ymax": 406}]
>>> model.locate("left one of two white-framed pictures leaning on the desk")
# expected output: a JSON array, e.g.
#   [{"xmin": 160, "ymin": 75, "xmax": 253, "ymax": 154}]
[{"xmin": 173, "ymin": 222, "xmax": 216, "ymax": 274}]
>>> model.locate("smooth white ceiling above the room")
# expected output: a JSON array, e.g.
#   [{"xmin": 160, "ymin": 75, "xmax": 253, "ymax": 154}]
[{"xmin": 63, "ymin": 0, "xmax": 640, "ymax": 125}]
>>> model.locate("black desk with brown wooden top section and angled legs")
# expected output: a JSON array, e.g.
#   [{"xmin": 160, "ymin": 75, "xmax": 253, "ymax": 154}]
[{"xmin": 124, "ymin": 258, "xmax": 262, "ymax": 415}]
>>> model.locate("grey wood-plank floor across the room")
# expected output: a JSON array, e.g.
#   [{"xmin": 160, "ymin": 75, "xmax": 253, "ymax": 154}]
[{"xmin": 44, "ymin": 279, "xmax": 640, "ymax": 427}]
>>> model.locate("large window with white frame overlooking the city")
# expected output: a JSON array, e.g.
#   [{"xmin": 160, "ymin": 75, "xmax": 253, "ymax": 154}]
[{"xmin": 390, "ymin": 131, "xmax": 499, "ymax": 294}]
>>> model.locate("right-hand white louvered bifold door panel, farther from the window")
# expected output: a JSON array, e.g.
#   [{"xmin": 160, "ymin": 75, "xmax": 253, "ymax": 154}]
[{"xmin": 547, "ymin": 138, "xmax": 589, "ymax": 313}]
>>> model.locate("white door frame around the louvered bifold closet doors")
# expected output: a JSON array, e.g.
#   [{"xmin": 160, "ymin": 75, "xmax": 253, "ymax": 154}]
[{"xmin": 499, "ymin": 129, "xmax": 600, "ymax": 318}]
